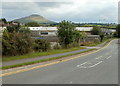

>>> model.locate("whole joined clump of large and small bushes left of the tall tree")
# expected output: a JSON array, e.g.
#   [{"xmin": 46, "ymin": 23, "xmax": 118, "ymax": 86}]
[{"xmin": 2, "ymin": 20, "xmax": 50, "ymax": 59}]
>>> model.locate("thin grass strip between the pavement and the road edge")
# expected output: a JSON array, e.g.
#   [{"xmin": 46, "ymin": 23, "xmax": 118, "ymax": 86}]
[{"xmin": 0, "ymin": 49, "xmax": 96, "ymax": 69}]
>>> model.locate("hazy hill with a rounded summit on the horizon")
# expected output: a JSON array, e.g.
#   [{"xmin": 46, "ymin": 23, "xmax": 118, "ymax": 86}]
[{"xmin": 13, "ymin": 14, "xmax": 56, "ymax": 24}]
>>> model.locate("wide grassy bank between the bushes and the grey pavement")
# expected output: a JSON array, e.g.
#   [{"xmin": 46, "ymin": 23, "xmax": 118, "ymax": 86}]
[{"xmin": 2, "ymin": 47, "xmax": 85, "ymax": 61}]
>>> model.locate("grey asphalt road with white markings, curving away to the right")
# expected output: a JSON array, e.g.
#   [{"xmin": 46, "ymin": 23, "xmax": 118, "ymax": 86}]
[{"xmin": 2, "ymin": 39, "xmax": 118, "ymax": 84}]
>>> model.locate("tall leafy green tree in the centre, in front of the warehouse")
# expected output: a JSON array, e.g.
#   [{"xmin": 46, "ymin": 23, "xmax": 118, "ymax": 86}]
[{"xmin": 57, "ymin": 20, "xmax": 79, "ymax": 48}]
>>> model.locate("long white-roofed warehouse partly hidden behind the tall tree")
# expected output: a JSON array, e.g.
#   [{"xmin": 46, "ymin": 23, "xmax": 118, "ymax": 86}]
[{"xmin": 28, "ymin": 27, "xmax": 93, "ymax": 37}]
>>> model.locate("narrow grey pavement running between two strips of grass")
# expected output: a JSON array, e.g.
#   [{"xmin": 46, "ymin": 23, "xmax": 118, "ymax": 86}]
[{"xmin": 2, "ymin": 41, "xmax": 106, "ymax": 66}]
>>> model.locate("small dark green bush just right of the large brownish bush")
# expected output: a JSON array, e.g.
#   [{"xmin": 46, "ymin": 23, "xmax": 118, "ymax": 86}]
[{"xmin": 34, "ymin": 39, "xmax": 51, "ymax": 52}]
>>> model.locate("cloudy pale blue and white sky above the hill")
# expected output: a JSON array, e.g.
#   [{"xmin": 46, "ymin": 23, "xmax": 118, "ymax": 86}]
[{"xmin": 0, "ymin": 0, "xmax": 119, "ymax": 23}]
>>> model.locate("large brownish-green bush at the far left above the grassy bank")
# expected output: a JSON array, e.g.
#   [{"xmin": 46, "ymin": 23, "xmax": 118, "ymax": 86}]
[{"xmin": 2, "ymin": 30, "xmax": 34, "ymax": 56}]
